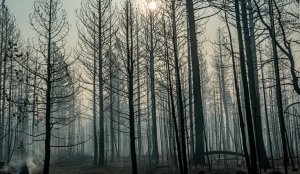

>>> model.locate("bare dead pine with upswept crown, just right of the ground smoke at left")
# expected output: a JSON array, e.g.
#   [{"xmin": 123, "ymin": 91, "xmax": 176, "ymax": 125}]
[{"xmin": 30, "ymin": 0, "xmax": 70, "ymax": 174}]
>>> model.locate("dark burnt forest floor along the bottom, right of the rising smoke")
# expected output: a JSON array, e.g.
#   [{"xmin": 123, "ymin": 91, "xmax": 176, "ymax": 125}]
[{"xmin": 50, "ymin": 158, "xmax": 300, "ymax": 174}]
